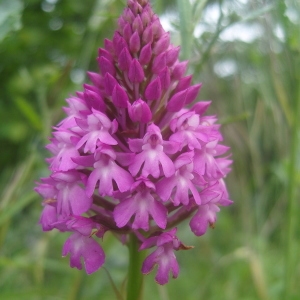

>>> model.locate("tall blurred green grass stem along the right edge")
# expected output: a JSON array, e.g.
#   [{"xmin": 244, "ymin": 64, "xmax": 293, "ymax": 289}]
[{"xmin": 284, "ymin": 58, "xmax": 300, "ymax": 300}]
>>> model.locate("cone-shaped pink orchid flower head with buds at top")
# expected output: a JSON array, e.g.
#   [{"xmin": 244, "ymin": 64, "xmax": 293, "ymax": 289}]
[{"xmin": 36, "ymin": 0, "xmax": 232, "ymax": 284}]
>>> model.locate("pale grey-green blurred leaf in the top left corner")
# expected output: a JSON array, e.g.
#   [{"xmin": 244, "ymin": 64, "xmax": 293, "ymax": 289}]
[{"xmin": 0, "ymin": 0, "xmax": 23, "ymax": 42}]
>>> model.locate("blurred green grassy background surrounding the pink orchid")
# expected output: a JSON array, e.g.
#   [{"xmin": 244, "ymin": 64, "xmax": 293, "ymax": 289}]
[{"xmin": 0, "ymin": 0, "xmax": 300, "ymax": 300}]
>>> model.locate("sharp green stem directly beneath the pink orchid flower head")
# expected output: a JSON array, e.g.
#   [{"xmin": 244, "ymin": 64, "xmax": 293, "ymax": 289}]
[{"xmin": 126, "ymin": 234, "xmax": 144, "ymax": 300}]
